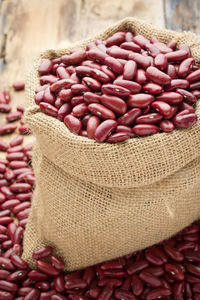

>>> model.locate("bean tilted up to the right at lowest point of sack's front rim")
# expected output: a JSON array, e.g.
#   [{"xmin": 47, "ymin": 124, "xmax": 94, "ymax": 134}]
[{"xmin": 94, "ymin": 120, "xmax": 117, "ymax": 142}]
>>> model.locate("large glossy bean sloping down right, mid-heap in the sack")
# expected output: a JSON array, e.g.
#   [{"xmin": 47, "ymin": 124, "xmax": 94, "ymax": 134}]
[{"xmin": 101, "ymin": 95, "xmax": 127, "ymax": 114}]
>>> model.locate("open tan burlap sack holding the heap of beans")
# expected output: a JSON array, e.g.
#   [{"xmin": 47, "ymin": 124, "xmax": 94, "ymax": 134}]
[{"xmin": 23, "ymin": 18, "xmax": 200, "ymax": 270}]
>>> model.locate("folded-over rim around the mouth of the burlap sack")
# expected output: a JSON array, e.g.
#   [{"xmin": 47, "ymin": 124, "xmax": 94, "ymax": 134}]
[{"xmin": 25, "ymin": 18, "xmax": 200, "ymax": 188}]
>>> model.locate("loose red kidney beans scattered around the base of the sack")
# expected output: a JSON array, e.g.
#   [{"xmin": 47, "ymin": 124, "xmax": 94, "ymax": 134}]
[{"xmin": 0, "ymin": 83, "xmax": 200, "ymax": 300}]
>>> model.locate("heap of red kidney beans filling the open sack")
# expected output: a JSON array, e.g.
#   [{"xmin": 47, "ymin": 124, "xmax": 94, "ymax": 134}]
[{"xmin": 35, "ymin": 32, "xmax": 200, "ymax": 143}]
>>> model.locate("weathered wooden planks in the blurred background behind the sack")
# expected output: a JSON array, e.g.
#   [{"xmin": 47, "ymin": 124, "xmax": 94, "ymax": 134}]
[{"xmin": 0, "ymin": 0, "xmax": 200, "ymax": 148}]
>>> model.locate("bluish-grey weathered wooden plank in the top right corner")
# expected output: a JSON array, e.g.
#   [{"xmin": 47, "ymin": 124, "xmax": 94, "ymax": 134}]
[{"xmin": 164, "ymin": 0, "xmax": 200, "ymax": 34}]
